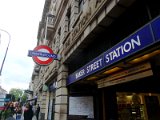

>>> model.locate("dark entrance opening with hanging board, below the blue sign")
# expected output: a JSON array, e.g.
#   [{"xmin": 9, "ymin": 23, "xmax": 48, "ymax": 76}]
[{"xmin": 97, "ymin": 57, "xmax": 160, "ymax": 120}]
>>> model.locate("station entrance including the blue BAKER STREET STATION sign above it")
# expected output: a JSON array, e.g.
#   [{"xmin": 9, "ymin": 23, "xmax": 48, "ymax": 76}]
[{"xmin": 67, "ymin": 16, "xmax": 160, "ymax": 120}]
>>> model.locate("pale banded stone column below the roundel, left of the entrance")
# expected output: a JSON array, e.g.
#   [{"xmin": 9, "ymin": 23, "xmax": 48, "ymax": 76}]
[{"xmin": 54, "ymin": 65, "xmax": 68, "ymax": 120}]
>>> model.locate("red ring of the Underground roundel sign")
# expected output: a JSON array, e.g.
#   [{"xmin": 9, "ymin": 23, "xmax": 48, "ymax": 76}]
[{"xmin": 32, "ymin": 45, "xmax": 54, "ymax": 65}]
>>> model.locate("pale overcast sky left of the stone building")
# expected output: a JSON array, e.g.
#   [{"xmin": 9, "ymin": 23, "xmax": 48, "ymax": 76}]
[{"xmin": 0, "ymin": 0, "xmax": 45, "ymax": 92}]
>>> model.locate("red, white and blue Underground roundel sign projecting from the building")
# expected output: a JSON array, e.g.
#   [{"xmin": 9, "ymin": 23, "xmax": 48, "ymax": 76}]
[{"xmin": 28, "ymin": 45, "xmax": 60, "ymax": 65}]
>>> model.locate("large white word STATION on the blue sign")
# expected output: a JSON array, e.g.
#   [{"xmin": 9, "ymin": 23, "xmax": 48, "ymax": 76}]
[{"xmin": 105, "ymin": 35, "xmax": 141, "ymax": 63}]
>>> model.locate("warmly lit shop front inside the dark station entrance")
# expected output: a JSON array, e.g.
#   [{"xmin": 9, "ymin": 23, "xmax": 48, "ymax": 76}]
[{"xmin": 117, "ymin": 92, "xmax": 160, "ymax": 120}]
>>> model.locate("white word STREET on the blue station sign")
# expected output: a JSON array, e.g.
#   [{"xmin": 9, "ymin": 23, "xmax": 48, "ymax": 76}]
[{"xmin": 87, "ymin": 58, "xmax": 102, "ymax": 73}]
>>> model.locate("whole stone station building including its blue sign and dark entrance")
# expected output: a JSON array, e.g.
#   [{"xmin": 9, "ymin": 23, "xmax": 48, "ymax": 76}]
[{"xmin": 32, "ymin": 0, "xmax": 160, "ymax": 120}]
